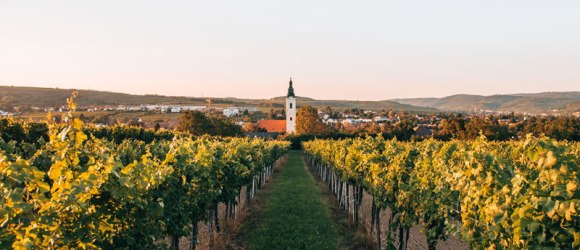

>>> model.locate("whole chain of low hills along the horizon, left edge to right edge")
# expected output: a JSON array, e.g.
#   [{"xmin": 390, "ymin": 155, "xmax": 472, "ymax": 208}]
[{"xmin": 0, "ymin": 86, "xmax": 580, "ymax": 113}]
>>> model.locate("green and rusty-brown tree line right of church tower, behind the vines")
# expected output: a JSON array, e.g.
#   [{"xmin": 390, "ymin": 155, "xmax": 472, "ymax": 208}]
[{"xmin": 296, "ymin": 106, "xmax": 580, "ymax": 141}]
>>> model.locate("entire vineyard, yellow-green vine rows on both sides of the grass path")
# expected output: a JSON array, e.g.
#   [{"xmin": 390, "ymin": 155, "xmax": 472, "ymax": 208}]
[{"xmin": 0, "ymin": 95, "xmax": 580, "ymax": 250}]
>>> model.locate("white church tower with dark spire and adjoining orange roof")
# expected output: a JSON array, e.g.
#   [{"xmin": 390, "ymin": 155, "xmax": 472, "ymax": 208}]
[{"xmin": 258, "ymin": 78, "xmax": 297, "ymax": 134}]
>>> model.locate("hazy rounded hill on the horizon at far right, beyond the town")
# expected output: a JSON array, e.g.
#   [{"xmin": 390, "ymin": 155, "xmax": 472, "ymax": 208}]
[{"xmin": 391, "ymin": 92, "xmax": 580, "ymax": 113}]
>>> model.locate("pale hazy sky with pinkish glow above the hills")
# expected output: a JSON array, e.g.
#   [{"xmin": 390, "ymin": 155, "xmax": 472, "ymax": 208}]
[{"xmin": 0, "ymin": 0, "xmax": 580, "ymax": 100}]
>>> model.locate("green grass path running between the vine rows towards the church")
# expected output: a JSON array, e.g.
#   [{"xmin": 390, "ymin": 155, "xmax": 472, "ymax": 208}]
[{"xmin": 247, "ymin": 151, "xmax": 340, "ymax": 249}]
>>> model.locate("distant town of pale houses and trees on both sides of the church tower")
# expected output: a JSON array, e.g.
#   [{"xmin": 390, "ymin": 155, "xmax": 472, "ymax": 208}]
[{"xmin": 0, "ymin": 99, "xmax": 580, "ymax": 142}]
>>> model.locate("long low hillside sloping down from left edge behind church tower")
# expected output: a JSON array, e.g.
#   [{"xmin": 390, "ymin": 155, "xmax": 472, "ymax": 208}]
[{"xmin": 0, "ymin": 86, "xmax": 437, "ymax": 112}]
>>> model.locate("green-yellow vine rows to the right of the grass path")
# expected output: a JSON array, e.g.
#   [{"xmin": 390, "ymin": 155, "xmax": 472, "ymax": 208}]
[{"xmin": 303, "ymin": 136, "xmax": 580, "ymax": 249}]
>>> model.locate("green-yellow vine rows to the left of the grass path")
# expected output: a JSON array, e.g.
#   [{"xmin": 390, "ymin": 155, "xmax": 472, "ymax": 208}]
[{"xmin": 0, "ymin": 96, "xmax": 289, "ymax": 249}]
